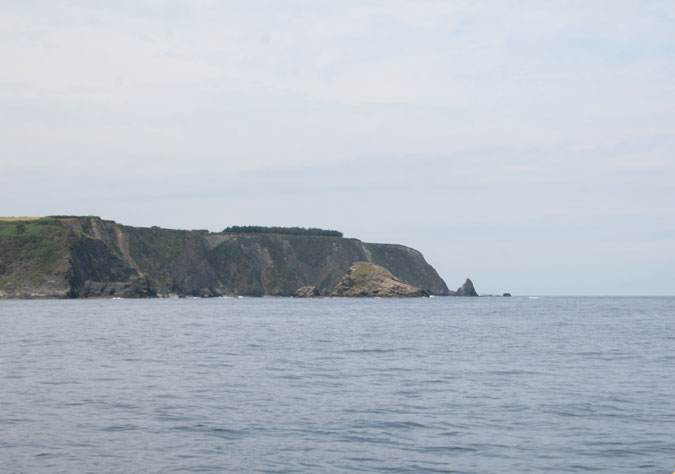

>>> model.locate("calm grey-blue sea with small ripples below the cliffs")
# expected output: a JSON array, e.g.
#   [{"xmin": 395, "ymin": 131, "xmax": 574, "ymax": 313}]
[{"xmin": 0, "ymin": 297, "xmax": 675, "ymax": 474}]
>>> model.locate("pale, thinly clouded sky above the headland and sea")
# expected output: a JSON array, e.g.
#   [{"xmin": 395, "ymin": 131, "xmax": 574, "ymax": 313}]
[{"xmin": 0, "ymin": 0, "xmax": 675, "ymax": 295}]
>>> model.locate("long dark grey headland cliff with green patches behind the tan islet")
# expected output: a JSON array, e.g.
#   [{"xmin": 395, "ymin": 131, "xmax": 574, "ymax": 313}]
[{"xmin": 0, "ymin": 217, "xmax": 449, "ymax": 298}]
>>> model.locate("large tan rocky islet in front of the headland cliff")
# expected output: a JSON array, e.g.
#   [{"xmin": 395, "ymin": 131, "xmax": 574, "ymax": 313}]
[{"xmin": 331, "ymin": 262, "xmax": 429, "ymax": 298}]
